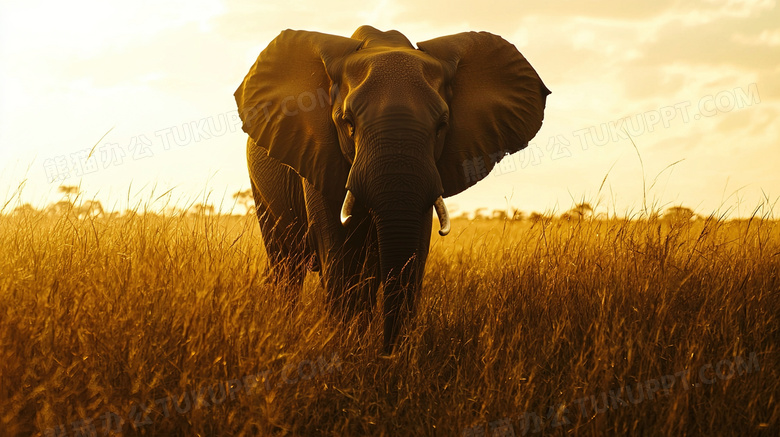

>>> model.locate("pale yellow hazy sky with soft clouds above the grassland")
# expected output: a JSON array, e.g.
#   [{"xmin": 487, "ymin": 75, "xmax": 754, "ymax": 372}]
[{"xmin": 0, "ymin": 0, "xmax": 780, "ymax": 217}]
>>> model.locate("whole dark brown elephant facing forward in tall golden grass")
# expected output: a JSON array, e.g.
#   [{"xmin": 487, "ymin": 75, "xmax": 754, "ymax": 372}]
[{"xmin": 234, "ymin": 26, "xmax": 550, "ymax": 355}]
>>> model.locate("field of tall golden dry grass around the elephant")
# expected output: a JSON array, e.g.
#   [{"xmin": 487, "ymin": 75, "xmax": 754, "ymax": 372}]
[{"xmin": 0, "ymin": 205, "xmax": 780, "ymax": 436}]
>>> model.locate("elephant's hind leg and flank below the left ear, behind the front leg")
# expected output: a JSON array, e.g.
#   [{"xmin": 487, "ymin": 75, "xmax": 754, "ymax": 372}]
[{"xmin": 247, "ymin": 145, "xmax": 311, "ymax": 295}]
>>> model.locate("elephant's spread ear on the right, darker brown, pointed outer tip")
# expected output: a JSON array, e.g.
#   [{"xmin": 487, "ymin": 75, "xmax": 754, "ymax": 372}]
[{"xmin": 417, "ymin": 32, "xmax": 550, "ymax": 197}]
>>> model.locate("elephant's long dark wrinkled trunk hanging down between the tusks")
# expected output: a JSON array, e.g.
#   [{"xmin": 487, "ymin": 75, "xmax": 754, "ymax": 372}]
[{"xmin": 341, "ymin": 134, "xmax": 448, "ymax": 353}]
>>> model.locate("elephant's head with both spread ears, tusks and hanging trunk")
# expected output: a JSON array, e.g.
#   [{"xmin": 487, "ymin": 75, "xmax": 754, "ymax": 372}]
[{"xmin": 235, "ymin": 26, "xmax": 549, "ymax": 350}]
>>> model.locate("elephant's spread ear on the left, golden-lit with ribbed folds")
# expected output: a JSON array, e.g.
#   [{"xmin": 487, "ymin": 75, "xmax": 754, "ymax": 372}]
[{"xmin": 234, "ymin": 30, "xmax": 361, "ymax": 201}]
